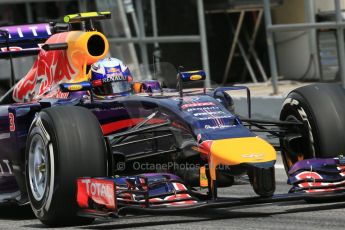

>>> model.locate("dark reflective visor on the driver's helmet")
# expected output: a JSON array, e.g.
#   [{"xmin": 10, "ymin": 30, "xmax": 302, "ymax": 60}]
[{"xmin": 94, "ymin": 81, "xmax": 131, "ymax": 96}]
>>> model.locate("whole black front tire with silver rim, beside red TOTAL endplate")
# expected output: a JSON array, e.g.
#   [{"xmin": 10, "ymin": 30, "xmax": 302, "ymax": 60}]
[{"xmin": 25, "ymin": 106, "xmax": 107, "ymax": 226}]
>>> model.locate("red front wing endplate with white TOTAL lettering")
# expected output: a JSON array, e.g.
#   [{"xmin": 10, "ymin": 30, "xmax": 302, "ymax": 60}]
[{"xmin": 77, "ymin": 178, "xmax": 117, "ymax": 211}]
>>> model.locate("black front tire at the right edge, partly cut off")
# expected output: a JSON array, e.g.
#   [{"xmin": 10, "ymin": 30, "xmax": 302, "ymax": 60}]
[{"xmin": 280, "ymin": 83, "xmax": 345, "ymax": 172}]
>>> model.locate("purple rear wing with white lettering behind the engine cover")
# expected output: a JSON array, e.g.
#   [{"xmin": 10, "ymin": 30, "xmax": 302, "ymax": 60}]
[{"xmin": 0, "ymin": 23, "xmax": 53, "ymax": 59}]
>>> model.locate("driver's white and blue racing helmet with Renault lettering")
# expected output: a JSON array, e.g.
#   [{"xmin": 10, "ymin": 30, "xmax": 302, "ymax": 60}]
[{"xmin": 91, "ymin": 57, "xmax": 133, "ymax": 97}]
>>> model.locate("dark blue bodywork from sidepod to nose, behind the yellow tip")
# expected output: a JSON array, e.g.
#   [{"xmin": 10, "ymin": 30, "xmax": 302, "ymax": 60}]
[{"xmin": 0, "ymin": 87, "xmax": 250, "ymax": 204}]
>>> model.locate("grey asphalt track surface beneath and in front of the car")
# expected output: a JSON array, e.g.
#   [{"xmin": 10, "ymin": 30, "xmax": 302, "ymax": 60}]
[{"xmin": 0, "ymin": 159, "xmax": 345, "ymax": 230}]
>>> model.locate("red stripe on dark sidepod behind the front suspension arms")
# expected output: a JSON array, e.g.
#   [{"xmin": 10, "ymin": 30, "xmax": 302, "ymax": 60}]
[{"xmin": 102, "ymin": 118, "xmax": 165, "ymax": 135}]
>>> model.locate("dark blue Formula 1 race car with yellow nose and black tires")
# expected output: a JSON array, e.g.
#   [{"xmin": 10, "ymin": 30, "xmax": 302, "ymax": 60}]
[{"xmin": 0, "ymin": 12, "xmax": 345, "ymax": 226}]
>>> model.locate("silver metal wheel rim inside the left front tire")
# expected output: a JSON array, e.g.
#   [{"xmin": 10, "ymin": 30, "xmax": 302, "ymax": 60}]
[{"xmin": 28, "ymin": 134, "xmax": 48, "ymax": 201}]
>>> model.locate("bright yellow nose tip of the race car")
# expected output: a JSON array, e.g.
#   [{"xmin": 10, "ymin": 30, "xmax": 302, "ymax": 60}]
[{"xmin": 209, "ymin": 137, "xmax": 277, "ymax": 184}]
